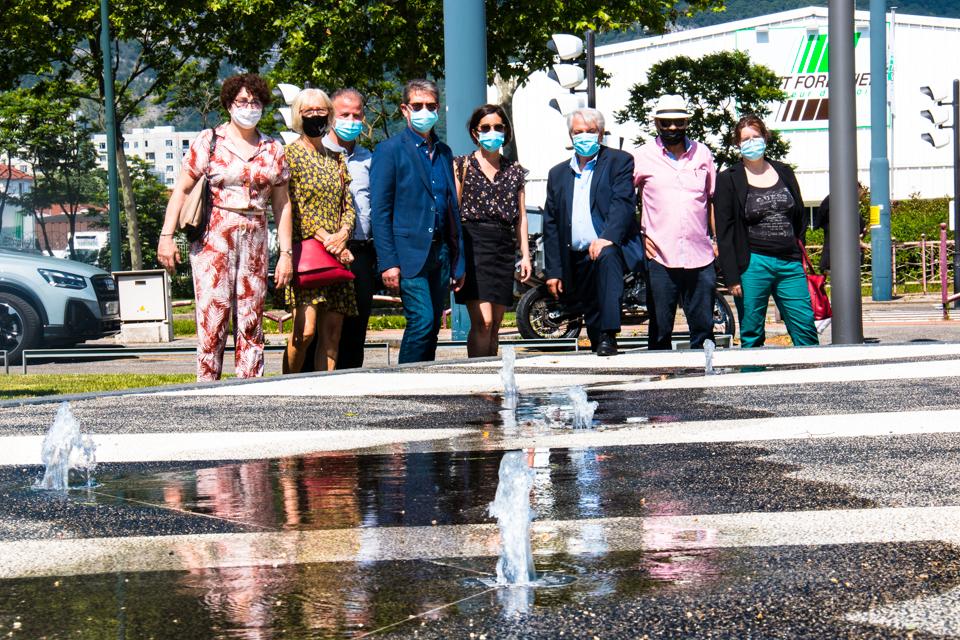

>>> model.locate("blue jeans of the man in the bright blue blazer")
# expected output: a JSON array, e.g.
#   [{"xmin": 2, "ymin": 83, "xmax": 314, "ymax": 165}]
[{"xmin": 399, "ymin": 242, "xmax": 450, "ymax": 364}]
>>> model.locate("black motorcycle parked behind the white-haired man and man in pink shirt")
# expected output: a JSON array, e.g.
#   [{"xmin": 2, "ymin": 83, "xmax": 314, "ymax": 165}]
[{"xmin": 517, "ymin": 235, "xmax": 736, "ymax": 340}]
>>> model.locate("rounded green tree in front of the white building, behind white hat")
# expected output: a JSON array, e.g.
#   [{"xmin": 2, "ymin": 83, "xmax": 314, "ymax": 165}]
[{"xmin": 616, "ymin": 51, "xmax": 789, "ymax": 167}]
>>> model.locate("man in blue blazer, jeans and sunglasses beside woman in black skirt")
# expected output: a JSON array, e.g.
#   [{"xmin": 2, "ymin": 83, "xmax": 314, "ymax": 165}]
[{"xmin": 370, "ymin": 80, "xmax": 464, "ymax": 363}]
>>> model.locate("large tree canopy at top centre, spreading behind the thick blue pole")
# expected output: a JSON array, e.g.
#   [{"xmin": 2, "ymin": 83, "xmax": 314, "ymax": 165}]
[{"xmin": 266, "ymin": 0, "xmax": 723, "ymax": 136}]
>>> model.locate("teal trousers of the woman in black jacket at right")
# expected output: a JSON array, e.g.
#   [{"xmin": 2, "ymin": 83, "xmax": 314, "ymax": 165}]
[{"xmin": 734, "ymin": 253, "xmax": 820, "ymax": 348}]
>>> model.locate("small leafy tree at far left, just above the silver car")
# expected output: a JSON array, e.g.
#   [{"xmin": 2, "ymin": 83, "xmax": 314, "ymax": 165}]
[{"xmin": 0, "ymin": 86, "xmax": 100, "ymax": 258}]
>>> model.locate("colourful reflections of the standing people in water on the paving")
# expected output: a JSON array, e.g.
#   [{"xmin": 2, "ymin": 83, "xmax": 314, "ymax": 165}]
[{"xmin": 62, "ymin": 448, "xmax": 717, "ymax": 639}]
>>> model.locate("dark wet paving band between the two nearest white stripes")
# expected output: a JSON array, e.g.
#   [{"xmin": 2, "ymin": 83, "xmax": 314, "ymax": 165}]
[{"xmin": 0, "ymin": 444, "xmax": 874, "ymax": 537}]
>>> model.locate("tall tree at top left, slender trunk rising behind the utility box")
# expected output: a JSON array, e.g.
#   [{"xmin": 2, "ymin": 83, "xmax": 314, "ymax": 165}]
[{"xmin": 0, "ymin": 0, "xmax": 276, "ymax": 269}]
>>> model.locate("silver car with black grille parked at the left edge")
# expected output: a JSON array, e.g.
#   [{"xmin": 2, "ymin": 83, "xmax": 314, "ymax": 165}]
[{"xmin": 0, "ymin": 249, "xmax": 120, "ymax": 364}]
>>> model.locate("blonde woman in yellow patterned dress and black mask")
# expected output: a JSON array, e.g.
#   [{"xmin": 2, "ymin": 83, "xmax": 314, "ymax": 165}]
[{"xmin": 283, "ymin": 89, "xmax": 357, "ymax": 373}]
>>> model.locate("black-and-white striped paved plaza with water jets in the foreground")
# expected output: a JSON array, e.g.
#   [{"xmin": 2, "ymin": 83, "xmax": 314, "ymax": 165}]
[{"xmin": 0, "ymin": 343, "xmax": 960, "ymax": 639}]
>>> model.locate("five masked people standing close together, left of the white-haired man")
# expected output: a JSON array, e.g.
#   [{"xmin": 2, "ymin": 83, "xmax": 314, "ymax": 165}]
[{"xmin": 157, "ymin": 74, "xmax": 532, "ymax": 381}]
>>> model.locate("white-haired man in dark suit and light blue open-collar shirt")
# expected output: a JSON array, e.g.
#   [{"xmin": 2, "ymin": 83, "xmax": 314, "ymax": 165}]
[{"xmin": 543, "ymin": 109, "xmax": 643, "ymax": 356}]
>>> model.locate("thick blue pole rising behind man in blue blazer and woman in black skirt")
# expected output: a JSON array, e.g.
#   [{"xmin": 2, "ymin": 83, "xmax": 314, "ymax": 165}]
[{"xmin": 443, "ymin": 0, "xmax": 487, "ymax": 340}]
